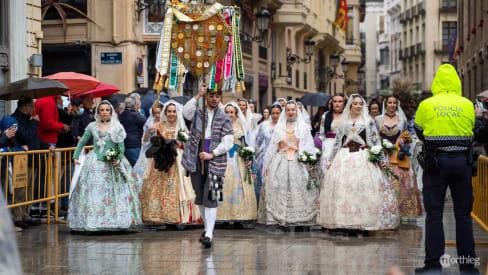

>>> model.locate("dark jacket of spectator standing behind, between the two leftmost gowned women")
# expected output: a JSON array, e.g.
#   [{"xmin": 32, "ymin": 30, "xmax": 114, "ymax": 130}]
[{"xmin": 119, "ymin": 108, "xmax": 146, "ymax": 148}]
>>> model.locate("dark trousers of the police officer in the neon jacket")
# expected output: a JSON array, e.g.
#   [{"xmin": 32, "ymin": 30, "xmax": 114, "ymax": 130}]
[{"xmin": 422, "ymin": 153, "xmax": 476, "ymax": 269}]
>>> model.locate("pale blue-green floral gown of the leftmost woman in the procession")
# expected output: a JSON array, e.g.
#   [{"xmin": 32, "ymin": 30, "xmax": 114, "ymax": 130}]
[{"xmin": 68, "ymin": 121, "xmax": 142, "ymax": 231}]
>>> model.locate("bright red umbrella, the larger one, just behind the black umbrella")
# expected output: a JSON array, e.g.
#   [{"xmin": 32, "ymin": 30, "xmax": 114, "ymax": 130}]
[{"xmin": 43, "ymin": 72, "xmax": 100, "ymax": 95}]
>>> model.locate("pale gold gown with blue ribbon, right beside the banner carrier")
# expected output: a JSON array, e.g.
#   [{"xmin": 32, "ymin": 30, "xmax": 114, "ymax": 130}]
[{"xmin": 217, "ymin": 122, "xmax": 257, "ymax": 221}]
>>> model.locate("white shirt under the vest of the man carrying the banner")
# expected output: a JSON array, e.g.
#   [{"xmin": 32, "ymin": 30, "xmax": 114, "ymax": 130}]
[{"xmin": 183, "ymin": 97, "xmax": 234, "ymax": 156}]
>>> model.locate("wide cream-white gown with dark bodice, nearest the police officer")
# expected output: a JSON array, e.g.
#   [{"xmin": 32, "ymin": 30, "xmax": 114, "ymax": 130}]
[{"xmin": 318, "ymin": 117, "xmax": 400, "ymax": 230}]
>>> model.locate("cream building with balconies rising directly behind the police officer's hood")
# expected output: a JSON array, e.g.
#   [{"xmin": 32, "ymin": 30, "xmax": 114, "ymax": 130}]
[{"xmin": 400, "ymin": 0, "xmax": 454, "ymax": 92}]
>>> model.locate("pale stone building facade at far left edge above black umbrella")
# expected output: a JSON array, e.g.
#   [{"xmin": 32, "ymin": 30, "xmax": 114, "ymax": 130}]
[{"xmin": 0, "ymin": 0, "xmax": 43, "ymax": 117}]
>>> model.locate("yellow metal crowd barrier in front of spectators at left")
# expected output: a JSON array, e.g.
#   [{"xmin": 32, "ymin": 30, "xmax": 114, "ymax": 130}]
[{"xmin": 0, "ymin": 146, "xmax": 93, "ymax": 224}]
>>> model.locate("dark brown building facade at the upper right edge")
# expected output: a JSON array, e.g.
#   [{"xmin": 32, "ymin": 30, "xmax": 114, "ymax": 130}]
[{"xmin": 457, "ymin": 0, "xmax": 488, "ymax": 99}]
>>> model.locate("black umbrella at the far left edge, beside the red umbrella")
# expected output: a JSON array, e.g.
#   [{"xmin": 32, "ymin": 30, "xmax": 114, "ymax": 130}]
[{"xmin": 0, "ymin": 77, "xmax": 69, "ymax": 100}]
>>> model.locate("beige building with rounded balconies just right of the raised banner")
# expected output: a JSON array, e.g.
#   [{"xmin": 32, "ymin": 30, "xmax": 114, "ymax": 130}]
[{"xmin": 268, "ymin": 0, "xmax": 346, "ymax": 100}]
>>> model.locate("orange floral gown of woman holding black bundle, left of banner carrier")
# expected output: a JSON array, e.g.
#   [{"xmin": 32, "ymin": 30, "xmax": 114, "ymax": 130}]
[{"xmin": 140, "ymin": 122, "xmax": 200, "ymax": 224}]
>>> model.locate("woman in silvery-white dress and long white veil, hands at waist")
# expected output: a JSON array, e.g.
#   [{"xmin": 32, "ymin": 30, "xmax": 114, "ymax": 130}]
[{"xmin": 258, "ymin": 101, "xmax": 318, "ymax": 226}]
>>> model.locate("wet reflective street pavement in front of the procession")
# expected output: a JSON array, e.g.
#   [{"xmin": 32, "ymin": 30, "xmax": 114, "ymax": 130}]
[{"xmin": 17, "ymin": 203, "xmax": 488, "ymax": 275}]
